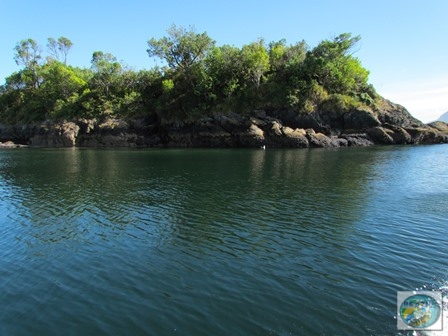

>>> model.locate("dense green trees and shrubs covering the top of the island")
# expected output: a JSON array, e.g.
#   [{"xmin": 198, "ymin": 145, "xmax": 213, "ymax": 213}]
[{"xmin": 0, "ymin": 25, "xmax": 376, "ymax": 124}]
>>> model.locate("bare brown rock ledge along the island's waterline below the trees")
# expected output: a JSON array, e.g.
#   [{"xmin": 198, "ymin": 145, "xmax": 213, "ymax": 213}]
[{"xmin": 0, "ymin": 101, "xmax": 448, "ymax": 148}]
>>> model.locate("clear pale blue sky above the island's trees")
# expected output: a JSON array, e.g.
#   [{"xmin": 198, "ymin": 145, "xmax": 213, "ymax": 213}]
[{"xmin": 0, "ymin": 0, "xmax": 448, "ymax": 122}]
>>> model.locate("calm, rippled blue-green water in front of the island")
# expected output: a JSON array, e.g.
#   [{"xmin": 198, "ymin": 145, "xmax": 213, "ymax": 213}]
[{"xmin": 0, "ymin": 145, "xmax": 448, "ymax": 336}]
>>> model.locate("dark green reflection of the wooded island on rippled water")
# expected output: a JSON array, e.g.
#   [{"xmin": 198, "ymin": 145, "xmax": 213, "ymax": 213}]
[{"xmin": 2, "ymin": 149, "xmax": 378, "ymax": 249}]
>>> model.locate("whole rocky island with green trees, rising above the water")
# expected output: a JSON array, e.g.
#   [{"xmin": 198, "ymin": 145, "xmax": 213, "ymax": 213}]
[{"xmin": 0, "ymin": 26, "xmax": 448, "ymax": 148}]
